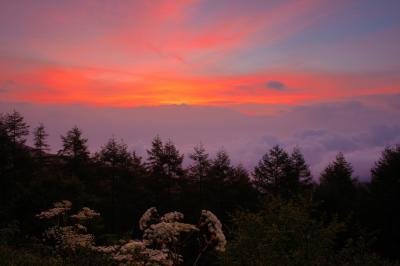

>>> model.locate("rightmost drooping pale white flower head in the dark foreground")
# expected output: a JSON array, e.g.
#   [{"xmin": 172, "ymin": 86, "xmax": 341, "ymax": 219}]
[{"xmin": 199, "ymin": 210, "xmax": 226, "ymax": 252}]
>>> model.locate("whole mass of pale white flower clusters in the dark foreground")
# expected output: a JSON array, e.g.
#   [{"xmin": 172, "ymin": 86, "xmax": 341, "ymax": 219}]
[{"xmin": 36, "ymin": 203, "xmax": 226, "ymax": 266}]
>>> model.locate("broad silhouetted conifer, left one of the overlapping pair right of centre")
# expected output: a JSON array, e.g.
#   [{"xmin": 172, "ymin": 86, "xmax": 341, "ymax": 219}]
[{"xmin": 253, "ymin": 146, "xmax": 299, "ymax": 199}]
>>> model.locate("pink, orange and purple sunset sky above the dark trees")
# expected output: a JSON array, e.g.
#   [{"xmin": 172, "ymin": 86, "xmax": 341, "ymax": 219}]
[{"xmin": 0, "ymin": 0, "xmax": 400, "ymax": 181}]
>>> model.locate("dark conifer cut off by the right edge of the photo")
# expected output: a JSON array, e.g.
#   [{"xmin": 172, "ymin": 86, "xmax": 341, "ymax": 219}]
[{"xmin": 371, "ymin": 145, "xmax": 400, "ymax": 258}]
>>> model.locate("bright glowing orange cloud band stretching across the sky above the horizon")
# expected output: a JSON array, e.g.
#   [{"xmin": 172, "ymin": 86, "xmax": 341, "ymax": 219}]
[{"xmin": 0, "ymin": 56, "xmax": 400, "ymax": 110}]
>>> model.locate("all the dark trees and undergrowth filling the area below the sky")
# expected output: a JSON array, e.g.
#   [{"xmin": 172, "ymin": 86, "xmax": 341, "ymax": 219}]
[{"xmin": 0, "ymin": 112, "xmax": 400, "ymax": 265}]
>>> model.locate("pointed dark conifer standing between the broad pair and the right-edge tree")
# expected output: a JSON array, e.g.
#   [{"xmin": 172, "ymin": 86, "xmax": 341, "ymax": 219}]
[{"xmin": 316, "ymin": 153, "xmax": 356, "ymax": 215}]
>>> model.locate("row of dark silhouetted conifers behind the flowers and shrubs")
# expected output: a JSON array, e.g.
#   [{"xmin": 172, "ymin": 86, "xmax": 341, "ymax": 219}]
[{"xmin": 0, "ymin": 111, "xmax": 400, "ymax": 265}]
